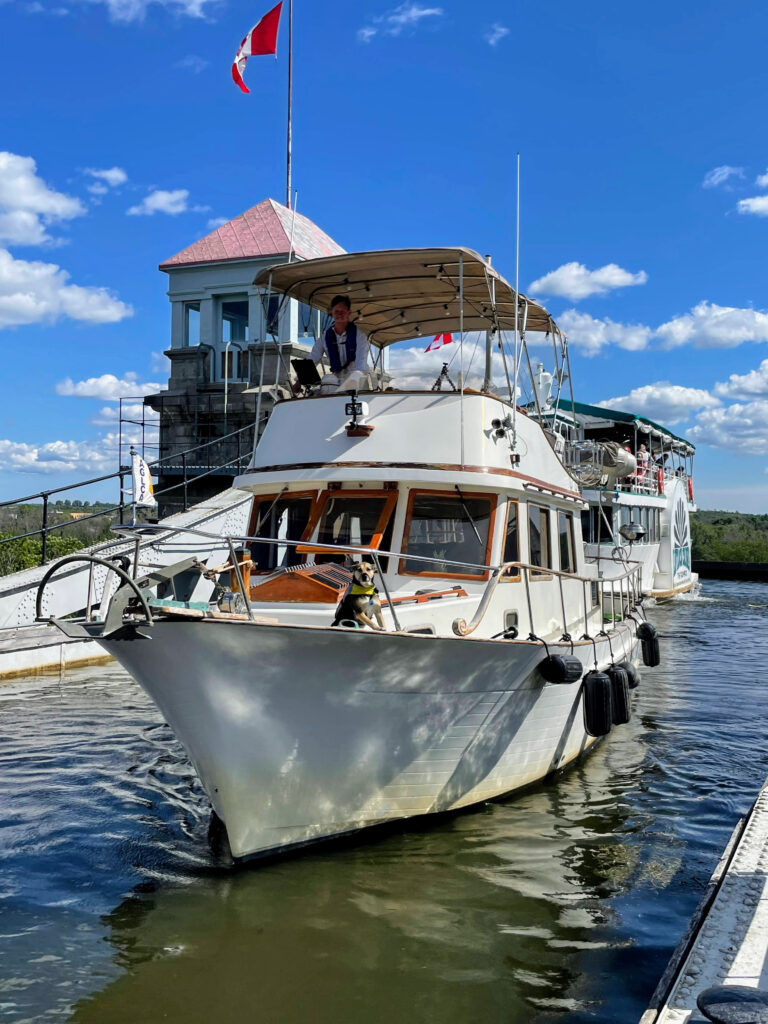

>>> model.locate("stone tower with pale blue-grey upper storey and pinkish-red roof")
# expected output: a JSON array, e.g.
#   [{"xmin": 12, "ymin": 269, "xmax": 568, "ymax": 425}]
[{"xmin": 144, "ymin": 199, "xmax": 344, "ymax": 516}]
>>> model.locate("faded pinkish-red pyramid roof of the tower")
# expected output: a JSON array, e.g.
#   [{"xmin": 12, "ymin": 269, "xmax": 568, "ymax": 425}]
[{"xmin": 160, "ymin": 199, "xmax": 344, "ymax": 270}]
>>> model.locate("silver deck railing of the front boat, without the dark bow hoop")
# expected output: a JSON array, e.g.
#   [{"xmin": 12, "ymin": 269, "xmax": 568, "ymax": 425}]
[{"xmin": 109, "ymin": 524, "xmax": 642, "ymax": 641}]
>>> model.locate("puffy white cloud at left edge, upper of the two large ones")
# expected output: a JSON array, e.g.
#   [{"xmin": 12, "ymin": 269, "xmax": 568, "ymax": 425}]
[{"xmin": 0, "ymin": 152, "xmax": 86, "ymax": 246}]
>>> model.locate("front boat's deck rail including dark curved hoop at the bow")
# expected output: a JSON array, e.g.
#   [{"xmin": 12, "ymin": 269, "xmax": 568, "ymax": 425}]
[{"xmin": 37, "ymin": 524, "xmax": 642, "ymax": 642}]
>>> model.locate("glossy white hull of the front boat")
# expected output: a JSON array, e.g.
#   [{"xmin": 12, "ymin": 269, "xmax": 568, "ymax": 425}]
[{"xmin": 100, "ymin": 620, "xmax": 634, "ymax": 858}]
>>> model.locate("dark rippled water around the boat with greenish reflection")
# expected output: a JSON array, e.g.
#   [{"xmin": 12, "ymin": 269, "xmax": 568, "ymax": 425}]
[{"xmin": 0, "ymin": 582, "xmax": 768, "ymax": 1024}]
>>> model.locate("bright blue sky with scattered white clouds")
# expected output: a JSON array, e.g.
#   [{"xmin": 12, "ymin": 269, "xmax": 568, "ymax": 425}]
[{"xmin": 0, "ymin": 0, "xmax": 768, "ymax": 512}]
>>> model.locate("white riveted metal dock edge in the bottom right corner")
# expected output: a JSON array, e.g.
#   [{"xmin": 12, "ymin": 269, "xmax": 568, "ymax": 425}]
[{"xmin": 640, "ymin": 780, "xmax": 768, "ymax": 1024}]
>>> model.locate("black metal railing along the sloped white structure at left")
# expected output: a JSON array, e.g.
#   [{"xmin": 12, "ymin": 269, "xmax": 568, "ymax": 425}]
[{"xmin": 0, "ymin": 425, "xmax": 259, "ymax": 565}]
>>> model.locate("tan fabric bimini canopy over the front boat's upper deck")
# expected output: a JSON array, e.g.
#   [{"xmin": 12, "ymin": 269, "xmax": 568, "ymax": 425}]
[{"xmin": 254, "ymin": 248, "xmax": 558, "ymax": 348}]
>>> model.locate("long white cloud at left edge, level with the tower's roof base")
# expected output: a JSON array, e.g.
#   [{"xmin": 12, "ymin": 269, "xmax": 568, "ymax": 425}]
[{"xmin": 0, "ymin": 249, "xmax": 133, "ymax": 328}]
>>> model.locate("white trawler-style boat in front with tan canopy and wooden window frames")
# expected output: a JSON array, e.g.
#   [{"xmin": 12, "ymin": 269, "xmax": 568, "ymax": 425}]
[{"xmin": 43, "ymin": 248, "xmax": 657, "ymax": 858}]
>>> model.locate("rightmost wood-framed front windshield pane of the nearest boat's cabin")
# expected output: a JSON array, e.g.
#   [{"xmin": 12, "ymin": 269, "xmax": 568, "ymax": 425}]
[{"xmin": 400, "ymin": 492, "xmax": 495, "ymax": 579}]
